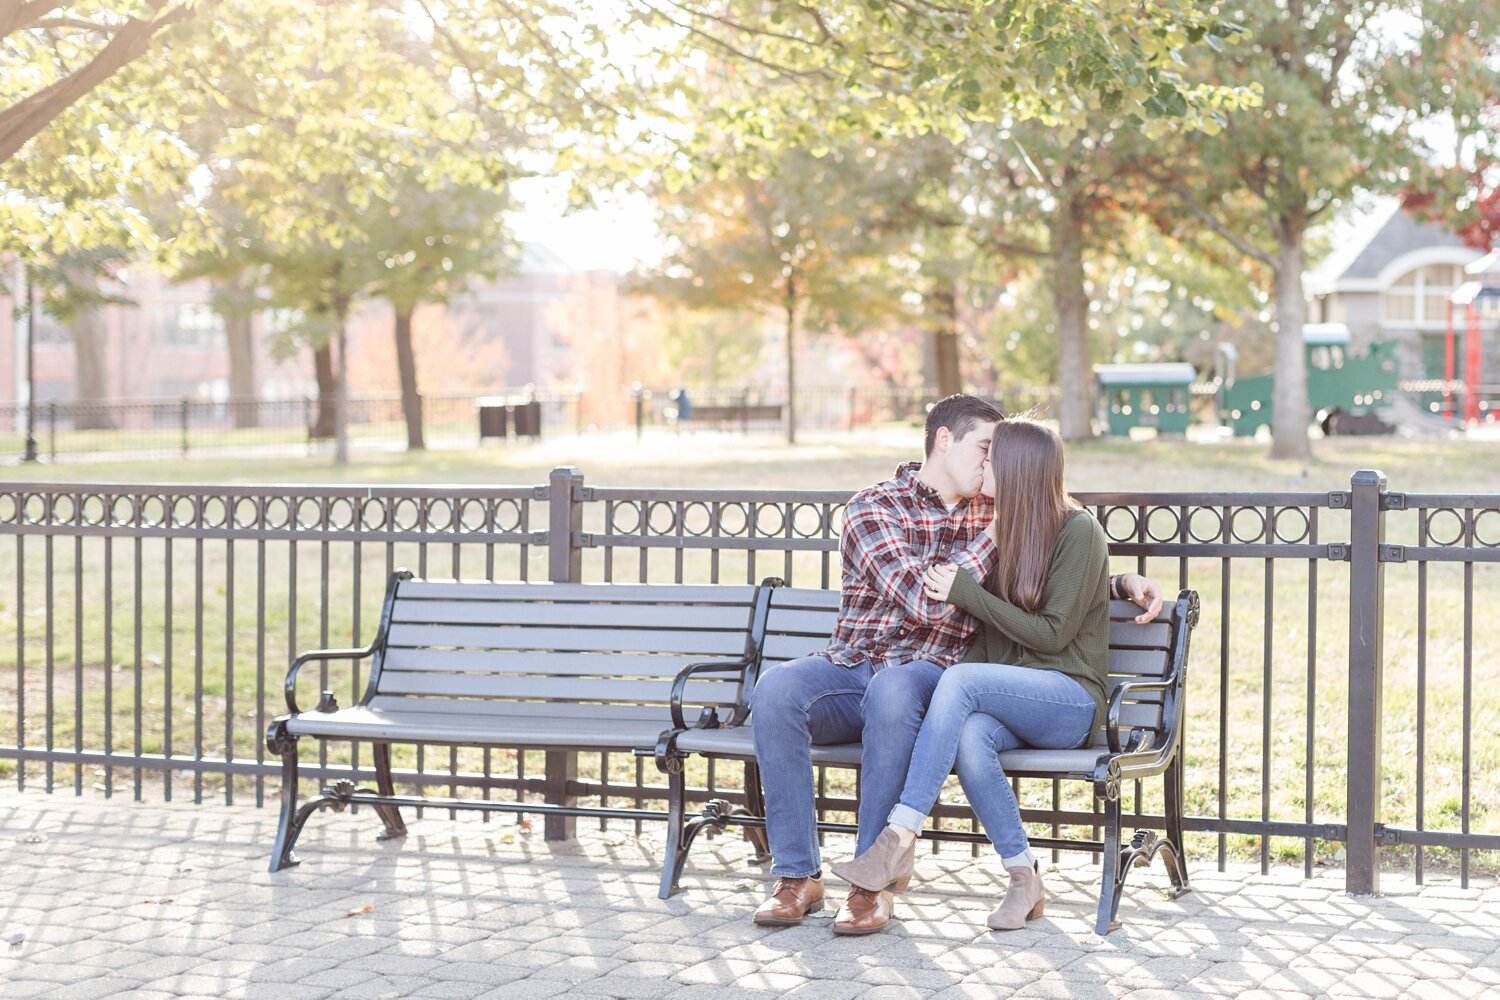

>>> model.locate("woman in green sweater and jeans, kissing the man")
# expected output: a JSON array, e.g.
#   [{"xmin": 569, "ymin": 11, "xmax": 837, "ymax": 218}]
[{"xmin": 834, "ymin": 420, "xmax": 1110, "ymax": 930}]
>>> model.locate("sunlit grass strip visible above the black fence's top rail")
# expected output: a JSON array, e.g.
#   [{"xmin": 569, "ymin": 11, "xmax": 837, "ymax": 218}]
[{"xmin": 5, "ymin": 427, "xmax": 1500, "ymax": 493}]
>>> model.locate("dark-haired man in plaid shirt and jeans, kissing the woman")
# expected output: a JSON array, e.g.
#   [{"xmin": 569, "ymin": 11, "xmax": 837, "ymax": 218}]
[{"xmin": 753, "ymin": 396, "xmax": 1161, "ymax": 934}]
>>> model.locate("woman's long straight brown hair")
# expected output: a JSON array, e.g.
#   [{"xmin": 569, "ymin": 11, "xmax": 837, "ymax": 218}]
[{"xmin": 986, "ymin": 418, "xmax": 1079, "ymax": 613}]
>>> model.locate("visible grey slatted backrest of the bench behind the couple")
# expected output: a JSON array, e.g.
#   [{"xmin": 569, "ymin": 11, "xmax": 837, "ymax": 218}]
[{"xmin": 761, "ymin": 586, "xmax": 1188, "ymax": 745}]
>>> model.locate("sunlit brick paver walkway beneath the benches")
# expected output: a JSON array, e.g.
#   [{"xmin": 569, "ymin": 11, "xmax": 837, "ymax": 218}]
[{"xmin": 0, "ymin": 787, "xmax": 1500, "ymax": 1000}]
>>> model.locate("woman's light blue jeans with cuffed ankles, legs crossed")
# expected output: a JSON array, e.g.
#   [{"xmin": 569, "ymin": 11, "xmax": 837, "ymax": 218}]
[{"xmin": 890, "ymin": 663, "xmax": 1094, "ymax": 858}]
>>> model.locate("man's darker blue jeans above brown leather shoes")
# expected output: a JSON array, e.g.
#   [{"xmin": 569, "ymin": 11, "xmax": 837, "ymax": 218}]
[{"xmin": 750, "ymin": 657, "xmax": 942, "ymax": 877}]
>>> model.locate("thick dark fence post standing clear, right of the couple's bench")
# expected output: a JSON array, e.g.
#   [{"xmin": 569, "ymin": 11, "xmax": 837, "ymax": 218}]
[{"xmin": 1344, "ymin": 469, "xmax": 1386, "ymax": 895}]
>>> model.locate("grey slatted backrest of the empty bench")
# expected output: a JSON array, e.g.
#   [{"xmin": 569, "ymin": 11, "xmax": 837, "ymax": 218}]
[{"xmin": 366, "ymin": 579, "xmax": 758, "ymax": 720}]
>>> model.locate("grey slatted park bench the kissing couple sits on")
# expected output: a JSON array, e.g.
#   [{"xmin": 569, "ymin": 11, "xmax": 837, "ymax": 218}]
[{"xmin": 653, "ymin": 580, "xmax": 1199, "ymax": 934}]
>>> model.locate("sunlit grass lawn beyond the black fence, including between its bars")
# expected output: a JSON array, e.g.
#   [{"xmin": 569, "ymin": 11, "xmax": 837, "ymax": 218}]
[{"xmin": 0, "ymin": 427, "xmax": 1500, "ymax": 870}]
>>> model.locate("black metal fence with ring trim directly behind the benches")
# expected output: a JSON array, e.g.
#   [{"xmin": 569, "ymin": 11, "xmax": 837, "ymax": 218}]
[{"xmin": 0, "ymin": 469, "xmax": 1500, "ymax": 892}]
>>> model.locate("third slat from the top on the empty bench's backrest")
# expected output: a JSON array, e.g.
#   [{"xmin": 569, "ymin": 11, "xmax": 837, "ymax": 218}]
[{"xmin": 387, "ymin": 622, "xmax": 746, "ymax": 658}]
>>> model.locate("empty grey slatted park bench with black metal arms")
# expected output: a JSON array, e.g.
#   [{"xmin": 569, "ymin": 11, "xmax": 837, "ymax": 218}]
[{"xmin": 266, "ymin": 570, "xmax": 767, "ymax": 871}]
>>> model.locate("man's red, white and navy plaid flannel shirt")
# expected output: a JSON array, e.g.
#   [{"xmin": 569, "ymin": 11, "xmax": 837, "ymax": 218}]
[{"xmin": 822, "ymin": 462, "xmax": 996, "ymax": 670}]
